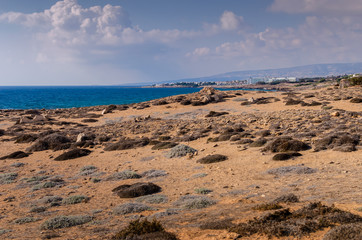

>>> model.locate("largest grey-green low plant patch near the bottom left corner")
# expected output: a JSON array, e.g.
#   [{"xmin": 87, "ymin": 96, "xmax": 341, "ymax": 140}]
[{"xmin": 40, "ymin": 215, "xmax": 92, "ymax": 230}]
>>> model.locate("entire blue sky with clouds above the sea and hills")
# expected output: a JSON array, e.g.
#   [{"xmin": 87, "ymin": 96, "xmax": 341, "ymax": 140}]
[{"xmin": 0, "ymin": 0, "xmax": 362, "ymax": 86}]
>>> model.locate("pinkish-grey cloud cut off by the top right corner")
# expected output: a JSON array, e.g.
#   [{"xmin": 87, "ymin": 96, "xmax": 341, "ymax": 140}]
[{"xmin": 270, "ymin": 0, "xmax": 362, "ymax": 15}]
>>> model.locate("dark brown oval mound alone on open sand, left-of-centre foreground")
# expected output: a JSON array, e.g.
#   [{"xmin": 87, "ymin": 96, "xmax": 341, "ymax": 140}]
[{"xmin": 112, "ymin": 183, "xmax": 161, "ymax": 198}]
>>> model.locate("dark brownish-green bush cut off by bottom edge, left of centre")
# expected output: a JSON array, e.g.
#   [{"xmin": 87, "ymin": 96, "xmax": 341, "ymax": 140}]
[{"xmin": 111, "ymin": 219, "xmax": 177, "ymax": 240}]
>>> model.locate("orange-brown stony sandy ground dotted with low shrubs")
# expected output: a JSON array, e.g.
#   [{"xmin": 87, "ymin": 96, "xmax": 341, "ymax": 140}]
[{"xmin": 0, "ymin": 85, "xmax": 362, "ymax": 239}]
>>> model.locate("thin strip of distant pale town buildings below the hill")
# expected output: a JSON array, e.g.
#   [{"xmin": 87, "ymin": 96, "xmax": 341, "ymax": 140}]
[{"xmin": 151, "ymin": 74, "xmax": 362, "ymax": 88}]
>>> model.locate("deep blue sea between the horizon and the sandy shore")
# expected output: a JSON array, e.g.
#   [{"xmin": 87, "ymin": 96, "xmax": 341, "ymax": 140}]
[{"xmin": 0, "ymin": 86, "xmax": 264, "ymax": 109}]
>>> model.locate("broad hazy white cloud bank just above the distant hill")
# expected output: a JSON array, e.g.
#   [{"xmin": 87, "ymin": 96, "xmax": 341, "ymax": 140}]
[{"xmin": 190, "ymin": 16, "xmax": 362, "ymax": 69}]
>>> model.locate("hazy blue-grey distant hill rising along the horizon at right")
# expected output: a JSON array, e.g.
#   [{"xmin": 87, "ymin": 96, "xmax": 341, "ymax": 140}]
[{"xmin": 169, "ymin": 63, "xmax": 362, "ymax": 83}]
